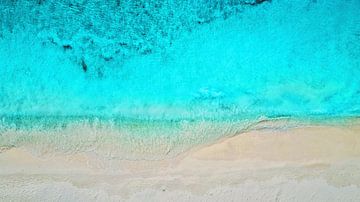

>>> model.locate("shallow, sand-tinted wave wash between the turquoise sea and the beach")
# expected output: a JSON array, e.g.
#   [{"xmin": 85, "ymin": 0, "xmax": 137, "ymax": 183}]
[{"xmin": 0, "ymin": 116, "xmax": 359, "ymax": 160}]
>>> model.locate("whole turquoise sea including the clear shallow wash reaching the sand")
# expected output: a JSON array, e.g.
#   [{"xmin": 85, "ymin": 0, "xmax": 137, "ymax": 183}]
[{"xmin": 0, "ymin": 0, "xmax": 360, "ymax": 158}]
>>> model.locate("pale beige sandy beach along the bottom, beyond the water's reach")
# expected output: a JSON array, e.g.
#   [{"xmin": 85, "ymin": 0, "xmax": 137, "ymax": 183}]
[{"xmin": 0, "ymin": 124, "xmax": 360, "ymax": 201}]
